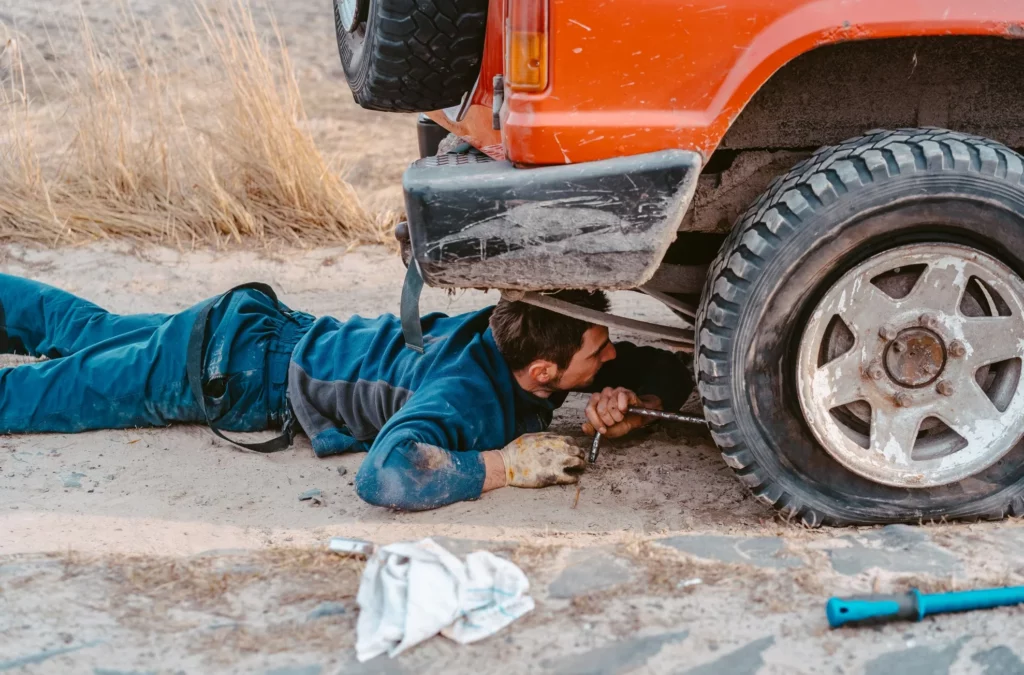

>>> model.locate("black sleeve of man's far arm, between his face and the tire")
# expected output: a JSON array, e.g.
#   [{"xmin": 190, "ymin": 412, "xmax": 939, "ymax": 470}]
[{"xmin": 585, "ymin": 342, "xmax": 693, "ymax": 411}]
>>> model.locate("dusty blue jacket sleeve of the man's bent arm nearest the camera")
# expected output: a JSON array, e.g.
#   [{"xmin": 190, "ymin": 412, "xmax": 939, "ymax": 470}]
[{"xmin": 355, "ymin": 381, "xmax": 491, "ymax": 511}]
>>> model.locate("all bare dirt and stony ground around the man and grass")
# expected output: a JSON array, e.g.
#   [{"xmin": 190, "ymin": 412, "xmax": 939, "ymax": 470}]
[{"xmin": 6, "ymin": 0, "xmax": 1024, "ymax": 675}]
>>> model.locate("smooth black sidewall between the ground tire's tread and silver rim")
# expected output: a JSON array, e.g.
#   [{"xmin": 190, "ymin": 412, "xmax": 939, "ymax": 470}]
[{"xmin": 730, "ymin": 171, "xmax": 1024, "ymax": 522}]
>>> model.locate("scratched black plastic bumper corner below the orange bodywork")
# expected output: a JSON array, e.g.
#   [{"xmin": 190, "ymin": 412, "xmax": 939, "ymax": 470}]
[{"xmin": 403, "ymin": 150, "xmax": 701, "ymax": 291}]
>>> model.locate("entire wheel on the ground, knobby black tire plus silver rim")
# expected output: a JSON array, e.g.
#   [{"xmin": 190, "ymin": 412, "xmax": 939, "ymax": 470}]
[{"xmin": 696, "ymin": 129, "xmax": 1024, "ymax": 525}]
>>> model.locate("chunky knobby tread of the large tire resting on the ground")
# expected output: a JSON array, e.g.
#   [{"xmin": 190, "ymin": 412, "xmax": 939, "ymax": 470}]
[{"xmin": 696, "ymin": 129, "xmax": 1024, "ymax": 526}]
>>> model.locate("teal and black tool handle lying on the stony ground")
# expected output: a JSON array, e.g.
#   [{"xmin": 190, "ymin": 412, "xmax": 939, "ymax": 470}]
[{"xmin": 825, "ymin": 586, "xmax": 1024, "ymax": 628}]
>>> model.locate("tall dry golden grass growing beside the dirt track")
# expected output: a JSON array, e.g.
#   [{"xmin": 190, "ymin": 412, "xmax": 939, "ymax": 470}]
[{"xmin": 0, "ymin": 0, "xmax": 396, "ymax": 248}]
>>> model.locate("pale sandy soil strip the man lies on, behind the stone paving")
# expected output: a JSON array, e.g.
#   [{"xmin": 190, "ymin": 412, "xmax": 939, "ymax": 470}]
[{"xmin": 0, "ymin": 241, "xmax": 753, "ymax": 554}]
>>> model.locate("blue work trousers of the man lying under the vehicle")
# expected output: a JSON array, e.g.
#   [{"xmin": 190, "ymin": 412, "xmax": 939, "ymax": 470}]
[{"xmin": 0, "ymin": 275, "xmax": 313, "ymax": 433}]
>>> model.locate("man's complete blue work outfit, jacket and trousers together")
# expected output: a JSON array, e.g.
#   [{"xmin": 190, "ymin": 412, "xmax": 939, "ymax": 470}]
[{"xmin": 0, "ymin": 275, "xmax": 692, "ymax": 510}]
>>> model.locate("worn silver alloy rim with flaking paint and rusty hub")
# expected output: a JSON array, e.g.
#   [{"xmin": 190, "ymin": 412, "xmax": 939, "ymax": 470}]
[{"xmin": 797, "ymin": 244, "xmax": 1024, "ymax": 488}]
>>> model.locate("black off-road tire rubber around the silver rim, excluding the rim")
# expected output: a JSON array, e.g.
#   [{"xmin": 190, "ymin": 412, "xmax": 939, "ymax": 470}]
[{"xmin": 696, "ymin": 129, "xmax": 1024, "ymax": 526}]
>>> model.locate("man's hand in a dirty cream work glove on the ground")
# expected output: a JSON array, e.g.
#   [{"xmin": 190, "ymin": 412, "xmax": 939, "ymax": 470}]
[{"xmin": 499, "ymin": 433, "xmax": 587, "ymax": 488}]
